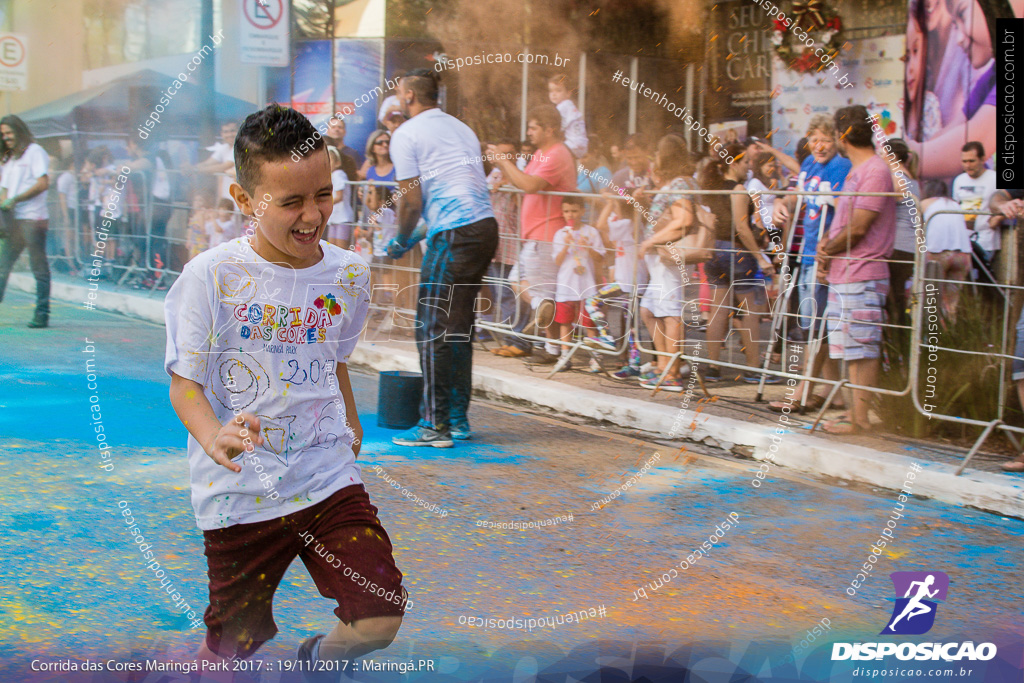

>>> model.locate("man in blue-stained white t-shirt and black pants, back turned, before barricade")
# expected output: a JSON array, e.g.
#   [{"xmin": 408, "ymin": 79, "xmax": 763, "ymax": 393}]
[{"xmin": 387, "ymin": 69, "xmax": 498, "ymax": 447}]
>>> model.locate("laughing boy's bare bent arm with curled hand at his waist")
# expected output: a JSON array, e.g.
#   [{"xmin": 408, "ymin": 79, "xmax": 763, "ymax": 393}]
[{"xmin": 171, "ymin": 372, "xmax": 264, "ymax": 472}]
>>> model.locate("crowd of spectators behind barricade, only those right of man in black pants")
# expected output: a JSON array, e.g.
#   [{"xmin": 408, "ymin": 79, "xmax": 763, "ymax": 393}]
[{"xmin": 454, "ymin": 98, "xmax": 1024, "ymax": 444}]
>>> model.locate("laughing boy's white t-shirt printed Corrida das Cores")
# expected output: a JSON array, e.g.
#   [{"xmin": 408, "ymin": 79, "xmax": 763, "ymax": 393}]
[{"xmin": 164, "ymin": 238, "xmax": 370, "ymax": 529}]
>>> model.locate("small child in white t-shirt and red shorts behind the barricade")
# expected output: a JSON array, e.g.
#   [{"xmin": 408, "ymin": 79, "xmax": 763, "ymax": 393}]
[{"xmin": 552, "ymin": 197, "xmax": 604, "ymax": 362}]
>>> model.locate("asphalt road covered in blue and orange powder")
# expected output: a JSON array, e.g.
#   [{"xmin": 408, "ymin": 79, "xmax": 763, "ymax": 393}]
[{"xmin": 0, "ymin": 292, "xmax": 1024, "ymax": 681}]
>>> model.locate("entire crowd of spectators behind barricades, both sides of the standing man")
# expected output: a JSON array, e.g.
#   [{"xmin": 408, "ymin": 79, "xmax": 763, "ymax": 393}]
[{"xmin": 14, "ymin": 75, "xmax": 1024, "ymax": 458}]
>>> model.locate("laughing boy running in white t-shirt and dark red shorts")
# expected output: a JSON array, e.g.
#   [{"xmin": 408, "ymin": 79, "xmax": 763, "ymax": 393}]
[{"xmin": 165, "ymin": 104, "xmax": 408, "ymax": 666}]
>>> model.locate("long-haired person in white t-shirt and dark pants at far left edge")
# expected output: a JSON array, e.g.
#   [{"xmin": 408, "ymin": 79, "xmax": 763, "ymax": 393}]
[{"xmin": 0, "ymin": 116, "xmax": 50, "ymax": 328}]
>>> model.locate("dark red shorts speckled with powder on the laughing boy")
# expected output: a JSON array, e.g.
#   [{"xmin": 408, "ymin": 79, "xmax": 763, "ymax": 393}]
[{"xmin": 203, "ymin": 484, "xmax": 412, "ymax": 657}]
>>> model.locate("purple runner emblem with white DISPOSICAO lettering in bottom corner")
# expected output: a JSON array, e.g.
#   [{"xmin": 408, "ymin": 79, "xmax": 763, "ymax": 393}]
[{"xmin": 831, "ymin": 571, "xmax": 996, "ymax": 661}]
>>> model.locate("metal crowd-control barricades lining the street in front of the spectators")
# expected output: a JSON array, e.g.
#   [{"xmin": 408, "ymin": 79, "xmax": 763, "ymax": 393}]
[{"xmin": 32, "ymin": 170, "xmax": 1024, "ymax": 462}]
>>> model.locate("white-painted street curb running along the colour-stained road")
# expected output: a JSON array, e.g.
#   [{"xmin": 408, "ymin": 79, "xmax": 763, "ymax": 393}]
[{"xmin": 18, "ymin": 273, "xmax": 1024, "ymax": 518}]
